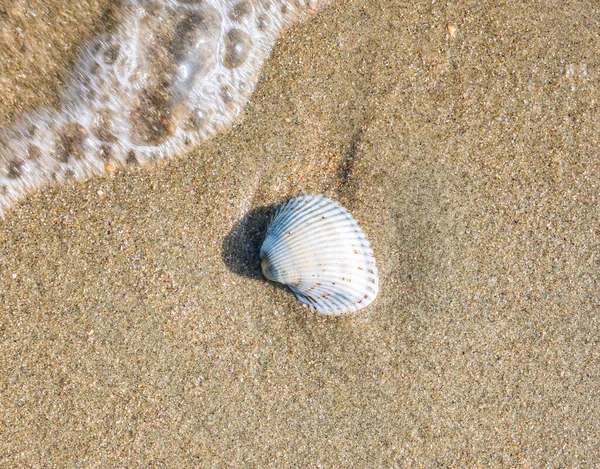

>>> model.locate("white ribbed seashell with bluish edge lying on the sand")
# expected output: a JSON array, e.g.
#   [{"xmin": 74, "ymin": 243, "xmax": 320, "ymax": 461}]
[{"xmin": 260, "ymin": 195, "xmax": 379, "ymax": 315}]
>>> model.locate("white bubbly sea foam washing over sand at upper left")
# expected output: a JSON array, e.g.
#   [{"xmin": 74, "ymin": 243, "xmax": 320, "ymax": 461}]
[{"xmin": 0, "ymin": 0, "xmax": 326, "ymax": 216}]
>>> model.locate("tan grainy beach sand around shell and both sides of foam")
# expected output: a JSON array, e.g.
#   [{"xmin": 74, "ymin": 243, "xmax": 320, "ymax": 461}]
[{"xmin": 0, "ymin": 0, "xmax": 600, "ymax": 468}]
